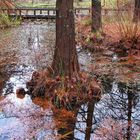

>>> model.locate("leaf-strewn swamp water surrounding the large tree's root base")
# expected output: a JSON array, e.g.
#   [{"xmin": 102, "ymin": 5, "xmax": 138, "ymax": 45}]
[{"xmin": 0, "ymin": 22, "xmax": 140, "ymax": 140}]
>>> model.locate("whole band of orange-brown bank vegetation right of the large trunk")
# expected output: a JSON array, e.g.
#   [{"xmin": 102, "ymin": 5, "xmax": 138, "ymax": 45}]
[{"xmin": 77, "ymin": 17, "xmax": 140, "ymax": 56}]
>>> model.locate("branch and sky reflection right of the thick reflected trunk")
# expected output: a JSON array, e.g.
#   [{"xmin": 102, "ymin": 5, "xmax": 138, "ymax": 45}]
[{"xmin": 95, "ymin": 82, "xmax": 140, "ymax": 140}]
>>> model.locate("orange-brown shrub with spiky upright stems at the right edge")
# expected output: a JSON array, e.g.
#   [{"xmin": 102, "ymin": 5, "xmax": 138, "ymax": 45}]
[{"xmin": 104, "ymin": 7, "xmax": 140, "ymax": 56}]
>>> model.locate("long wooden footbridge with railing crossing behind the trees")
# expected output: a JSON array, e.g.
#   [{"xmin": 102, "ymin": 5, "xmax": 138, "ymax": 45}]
[{"xmin": 0, "ymin": 8, "xmax": 128, "ymax": 19}]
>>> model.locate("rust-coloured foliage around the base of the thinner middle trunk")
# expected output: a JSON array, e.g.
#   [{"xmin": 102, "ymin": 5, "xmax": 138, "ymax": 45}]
[{"xmin": 76, "ymin": 16, "xmax": 105, "ymax": 52}]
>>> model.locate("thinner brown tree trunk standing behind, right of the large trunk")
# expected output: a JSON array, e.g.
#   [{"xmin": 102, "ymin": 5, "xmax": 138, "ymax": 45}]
[{"xmin": 92, "ymin": 0, "xmax": 102, "ymax": 32}]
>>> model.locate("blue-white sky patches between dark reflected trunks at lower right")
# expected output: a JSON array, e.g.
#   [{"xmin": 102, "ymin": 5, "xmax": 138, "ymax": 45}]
[{"xmin": 75, "ymin": 82, "xmax": 140, "ymax": 140}]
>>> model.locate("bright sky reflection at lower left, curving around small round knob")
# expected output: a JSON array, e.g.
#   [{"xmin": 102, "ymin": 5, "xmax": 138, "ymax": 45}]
[{"xmin": 0, "ymin": 62, "xmax": 56, "ymax": 140}]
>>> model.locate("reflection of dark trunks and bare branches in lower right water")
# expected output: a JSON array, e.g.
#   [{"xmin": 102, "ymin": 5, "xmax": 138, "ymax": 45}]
[{"xmin": 71, "ymin": 82, "xmax": 140, "ymax": 140}]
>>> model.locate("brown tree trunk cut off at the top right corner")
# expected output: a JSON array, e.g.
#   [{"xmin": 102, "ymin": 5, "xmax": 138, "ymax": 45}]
[{"xmin": 134, "ymin": 0, "xmax": 140, "ymax": 22}]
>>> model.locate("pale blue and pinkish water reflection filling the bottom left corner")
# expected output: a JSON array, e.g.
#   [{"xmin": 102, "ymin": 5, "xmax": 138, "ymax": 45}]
[{"xmin": 0, "ymin": 94, "xmax": 57, "ymax": 140}]
